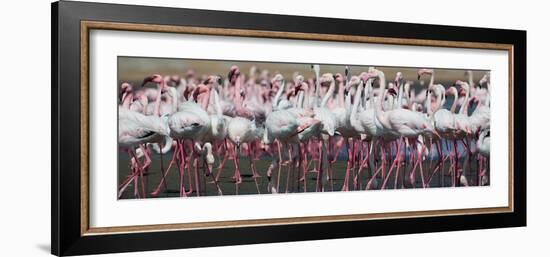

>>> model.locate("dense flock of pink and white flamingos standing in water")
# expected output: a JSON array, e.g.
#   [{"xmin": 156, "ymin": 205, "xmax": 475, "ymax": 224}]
[{"xmin": 117, "ymin": 64, "xmax": 491, "ymax": 198}]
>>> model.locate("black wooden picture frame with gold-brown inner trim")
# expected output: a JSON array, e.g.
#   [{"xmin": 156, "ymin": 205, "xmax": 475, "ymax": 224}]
[{"xmin": 51, "ymin": 1, "xmax": 526, "ymax": 255}]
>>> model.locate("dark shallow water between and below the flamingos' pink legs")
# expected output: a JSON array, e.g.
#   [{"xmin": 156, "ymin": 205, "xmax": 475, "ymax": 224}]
[{"xmin": 118, "ymin": 142, "xmax": 489, "ymax": 199}]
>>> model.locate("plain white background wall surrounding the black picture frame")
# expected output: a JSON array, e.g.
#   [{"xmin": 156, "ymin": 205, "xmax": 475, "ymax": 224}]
[{"xmin": 0, "ymin": 0, "xmax": 550, "ymax": 257}]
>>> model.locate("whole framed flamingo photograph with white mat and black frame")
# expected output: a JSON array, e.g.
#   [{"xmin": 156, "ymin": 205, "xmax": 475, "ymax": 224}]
[{"xmin": 51, "ymin": 1, "xmax": 526, "ymax": 255}]
